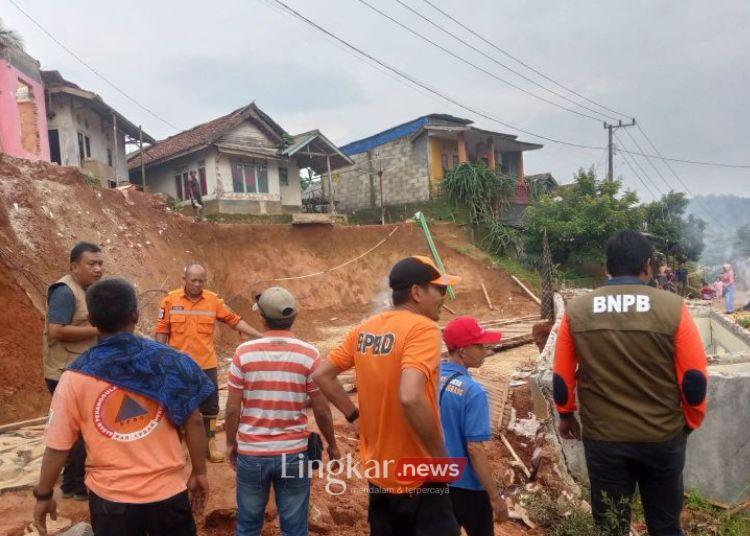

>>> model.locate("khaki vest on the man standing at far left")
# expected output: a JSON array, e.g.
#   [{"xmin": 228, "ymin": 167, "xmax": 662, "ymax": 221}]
[{"xmin": 42, "ymin": 274, "xmax": 98, "ymax": 381}]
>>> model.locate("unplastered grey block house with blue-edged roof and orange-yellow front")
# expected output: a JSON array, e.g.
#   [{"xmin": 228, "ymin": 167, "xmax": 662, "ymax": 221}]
[{"xmin": 338, "ymin": 114, "xmax": 542, "ymax": 212}]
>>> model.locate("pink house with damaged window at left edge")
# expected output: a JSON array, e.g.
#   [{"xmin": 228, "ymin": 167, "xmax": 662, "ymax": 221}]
[{"xmin": 0, "ymin": 41, "xmax": 49, "ymax": 161}]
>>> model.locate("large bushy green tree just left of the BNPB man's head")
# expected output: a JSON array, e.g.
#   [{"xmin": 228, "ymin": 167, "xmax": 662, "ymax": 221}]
[{"xmin": 524, "ymin": 168, "xmax": 644, "ymax": 267}]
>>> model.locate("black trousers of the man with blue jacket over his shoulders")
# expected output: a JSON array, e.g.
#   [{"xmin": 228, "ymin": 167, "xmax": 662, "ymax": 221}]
[{"xmin": 89, "ymin": 491, "xmax": 197, "ymax": 536}]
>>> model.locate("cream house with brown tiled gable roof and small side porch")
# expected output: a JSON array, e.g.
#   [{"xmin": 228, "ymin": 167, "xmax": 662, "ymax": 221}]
[{"xmin": 128, "ymin": 103, "xmax": 352, "ymax": 214}]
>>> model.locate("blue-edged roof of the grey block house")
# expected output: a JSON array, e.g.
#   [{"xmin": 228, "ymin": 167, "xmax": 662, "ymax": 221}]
[{"xmin": 341, "ymin": 114, "xmax": 542, "ymax": 155}]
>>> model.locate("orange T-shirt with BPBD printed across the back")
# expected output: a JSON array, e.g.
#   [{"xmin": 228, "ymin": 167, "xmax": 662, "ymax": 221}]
[{"xmin": 328, "ymin": 310, "xmax": 442, "ymax": 493}]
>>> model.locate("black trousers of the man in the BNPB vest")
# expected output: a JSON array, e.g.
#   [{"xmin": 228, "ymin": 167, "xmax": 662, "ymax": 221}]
[{"xmin": 583, "ymin": 432, "xmax": 687, "ymax": 536}]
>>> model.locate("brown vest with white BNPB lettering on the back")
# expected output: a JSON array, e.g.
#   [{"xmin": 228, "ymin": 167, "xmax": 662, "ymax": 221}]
[{"xmin": 567, "ymin": 284, "xmax": 685, "ymax": 442}]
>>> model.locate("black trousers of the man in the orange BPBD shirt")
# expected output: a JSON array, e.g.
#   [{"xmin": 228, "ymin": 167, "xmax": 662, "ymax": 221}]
[{"xmin": 367, "ymin": 483, "xmax": 461, "ymax": 536}]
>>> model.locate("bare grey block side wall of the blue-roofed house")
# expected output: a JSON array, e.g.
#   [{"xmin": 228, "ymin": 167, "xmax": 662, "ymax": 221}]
[{"xmin": 334, "ymin": 135, "xmax": 430, "ymax": 212}]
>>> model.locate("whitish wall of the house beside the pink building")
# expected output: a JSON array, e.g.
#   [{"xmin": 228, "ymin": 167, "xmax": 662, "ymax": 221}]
[{"xmin": 47, "ymin": 93, "xmax": 128, "ymax": 181}]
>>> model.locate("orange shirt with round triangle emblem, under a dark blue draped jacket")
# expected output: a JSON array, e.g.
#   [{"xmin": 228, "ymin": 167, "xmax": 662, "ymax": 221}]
[{"xmin": 44, "ymin": 371, "xmax": 186, "ymax": 503}]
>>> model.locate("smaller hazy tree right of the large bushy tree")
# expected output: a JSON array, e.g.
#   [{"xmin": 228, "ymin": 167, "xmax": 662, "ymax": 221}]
[{"xmin": 644, "ymin": 191, "xmax": 706, "ymax": 260}]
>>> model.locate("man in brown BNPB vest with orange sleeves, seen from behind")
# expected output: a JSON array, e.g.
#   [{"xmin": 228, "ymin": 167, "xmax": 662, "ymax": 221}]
[{"xmin": 553, "ymin": 231, "xmax": 707, "ymax": 536}]
